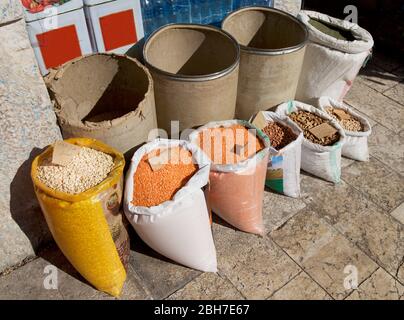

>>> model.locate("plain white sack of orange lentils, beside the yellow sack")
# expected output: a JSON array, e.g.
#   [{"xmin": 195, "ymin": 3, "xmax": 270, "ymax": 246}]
[{"xmin": 124, "ymin": 139, "xmax": 217, "ymax": 272}]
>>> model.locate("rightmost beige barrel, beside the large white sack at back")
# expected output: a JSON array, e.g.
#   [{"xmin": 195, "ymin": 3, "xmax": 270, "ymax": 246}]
[{"xmin": 222, "ymin": 7, "xmax": 308, "ymax": 120}]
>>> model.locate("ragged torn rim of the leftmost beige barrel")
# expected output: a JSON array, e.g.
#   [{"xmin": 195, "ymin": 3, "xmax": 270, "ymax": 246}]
[{"xmin": 45, "ymin": 52, "xmax": 154, "ymax": 132}]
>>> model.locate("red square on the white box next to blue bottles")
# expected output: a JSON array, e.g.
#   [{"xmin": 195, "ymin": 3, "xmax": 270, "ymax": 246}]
[{"xmin": 100, "ymin": 9, "xmax": 137, "ymax": 51}]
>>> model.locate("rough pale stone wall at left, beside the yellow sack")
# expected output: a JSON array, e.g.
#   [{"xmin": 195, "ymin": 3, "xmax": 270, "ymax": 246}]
[{"xmin": 0, "ymin": 0, "xmax": 61, "ymax": 272}]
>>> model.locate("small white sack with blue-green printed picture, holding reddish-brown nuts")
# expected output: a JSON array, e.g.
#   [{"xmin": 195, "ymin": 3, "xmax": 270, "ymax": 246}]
[{"xmin": 256, "ymin": 111, "xmax": 303, "ymax": 198}]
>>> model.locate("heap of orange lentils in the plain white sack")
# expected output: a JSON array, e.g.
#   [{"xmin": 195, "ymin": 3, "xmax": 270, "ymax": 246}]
[{"xmin": 132, "ymin": 147, "xmax": 198, "ymax": 207}]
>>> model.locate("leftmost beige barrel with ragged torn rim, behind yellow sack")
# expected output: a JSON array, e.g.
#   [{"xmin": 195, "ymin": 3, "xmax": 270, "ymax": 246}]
[{"xmin": 46, "ymin": 54, "xmax": 157, "ymax": 153}]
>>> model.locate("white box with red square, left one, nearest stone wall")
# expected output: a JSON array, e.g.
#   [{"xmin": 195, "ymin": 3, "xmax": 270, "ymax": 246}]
[{"xmin": 24, "ymin": 0, "xmax": 93, "ymax": 75}]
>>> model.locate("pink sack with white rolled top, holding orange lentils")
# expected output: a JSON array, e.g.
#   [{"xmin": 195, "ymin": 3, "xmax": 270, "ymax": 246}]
[{"xmin": 189, "ymin": 120, "xmax": 269, "ymax": 235}]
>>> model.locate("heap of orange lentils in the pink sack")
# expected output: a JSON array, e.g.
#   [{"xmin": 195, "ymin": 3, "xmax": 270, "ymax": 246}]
[{"xmin": 196, "ymin": 124, "xmax": 264, "ymax": 164}]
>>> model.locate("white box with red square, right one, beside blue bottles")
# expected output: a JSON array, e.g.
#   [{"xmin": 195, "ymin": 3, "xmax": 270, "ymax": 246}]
[{"xmin": 84, "ymin": 0, "xmax": 144, "ymax": 53}]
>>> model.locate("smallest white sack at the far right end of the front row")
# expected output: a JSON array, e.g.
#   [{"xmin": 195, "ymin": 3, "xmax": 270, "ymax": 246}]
[{"xmin": 318, "ymin": 97, "xmax": 372, "ymax": 161}]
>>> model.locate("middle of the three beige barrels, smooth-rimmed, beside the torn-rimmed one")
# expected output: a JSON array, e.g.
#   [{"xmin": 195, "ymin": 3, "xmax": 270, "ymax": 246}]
[{"xmin": 143, "ymin": 24, "xmax": 240, "ymax": 136}]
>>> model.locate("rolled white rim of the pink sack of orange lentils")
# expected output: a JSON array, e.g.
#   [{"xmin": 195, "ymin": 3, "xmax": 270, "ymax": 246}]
[{"xmin": 188, "ymin": 120, "xmax": 270, "ymax": 172}]
